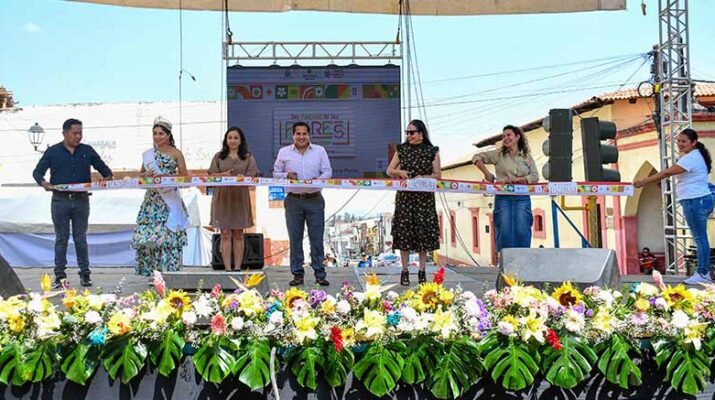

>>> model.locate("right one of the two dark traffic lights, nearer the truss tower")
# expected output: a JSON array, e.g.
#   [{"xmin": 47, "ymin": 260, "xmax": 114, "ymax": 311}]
[{"xmin": 581, "ymin": 117, "xmax": 621, "ymax": 182}]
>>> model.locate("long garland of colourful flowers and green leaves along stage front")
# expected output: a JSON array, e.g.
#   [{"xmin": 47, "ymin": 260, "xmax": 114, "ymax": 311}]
[{"xmin": 0, "ymin": 269, "xmax": 715, "ymax": 398}]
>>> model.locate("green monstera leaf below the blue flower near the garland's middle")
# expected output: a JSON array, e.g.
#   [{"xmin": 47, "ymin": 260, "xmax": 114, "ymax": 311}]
[{"xmin": 353, "ymin": 342, "xmax": 405, "ymax": 397}]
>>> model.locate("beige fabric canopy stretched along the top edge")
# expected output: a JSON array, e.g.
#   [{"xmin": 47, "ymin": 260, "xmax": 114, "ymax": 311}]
[{"xmin": 69, "ymin": 0, "xmax": 626, "ymax": 15}]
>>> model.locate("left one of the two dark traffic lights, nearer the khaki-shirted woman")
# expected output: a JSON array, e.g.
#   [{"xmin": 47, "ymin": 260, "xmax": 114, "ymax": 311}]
[{"xmin": 541, "ymin": 109, "xmax": 573, "ymax": 182}]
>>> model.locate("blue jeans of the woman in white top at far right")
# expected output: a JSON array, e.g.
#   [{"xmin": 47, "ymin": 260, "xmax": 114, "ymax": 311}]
[{"xmin": 680, "ymin": 195, "xmax": 715, "ymax": 276}]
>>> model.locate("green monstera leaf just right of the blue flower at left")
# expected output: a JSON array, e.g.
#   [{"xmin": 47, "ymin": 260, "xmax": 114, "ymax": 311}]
[{"xmin": 102, "ymin": 335, "xmax": 147, "ymax": 384}]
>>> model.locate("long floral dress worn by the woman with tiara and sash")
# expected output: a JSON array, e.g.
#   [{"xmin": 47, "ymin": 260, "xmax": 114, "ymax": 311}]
[{"xmin": 131, "ymin": 151, "xmax": 187, "ymax": 276}]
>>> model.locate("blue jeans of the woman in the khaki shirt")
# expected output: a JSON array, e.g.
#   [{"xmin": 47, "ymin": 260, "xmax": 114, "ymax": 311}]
[{"xmin": 494, "ymin": 196, "xmax": 534, "ymax": 252}]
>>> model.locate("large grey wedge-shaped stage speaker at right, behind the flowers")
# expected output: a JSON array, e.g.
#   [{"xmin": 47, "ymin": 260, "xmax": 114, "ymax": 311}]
[{"xmin": 497, "ymin": 249, "xmax": 621, "ymax": 289}]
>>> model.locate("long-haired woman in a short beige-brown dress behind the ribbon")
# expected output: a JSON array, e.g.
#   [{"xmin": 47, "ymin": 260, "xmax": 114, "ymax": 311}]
[{"xmin": 208, "ymin": 127, "xmax": 260, "ymax": 271}]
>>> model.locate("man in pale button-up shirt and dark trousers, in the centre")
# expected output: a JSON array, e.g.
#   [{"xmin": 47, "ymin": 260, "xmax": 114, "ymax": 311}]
[{"xmin": 273, "ymin": 122, "xmax": 333, "ymax": 286}]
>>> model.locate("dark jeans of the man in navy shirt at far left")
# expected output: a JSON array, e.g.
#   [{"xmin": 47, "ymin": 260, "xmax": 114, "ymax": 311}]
[{"xmin": 51, "ymin": 193, "xmax": 90, "ymax": 279}]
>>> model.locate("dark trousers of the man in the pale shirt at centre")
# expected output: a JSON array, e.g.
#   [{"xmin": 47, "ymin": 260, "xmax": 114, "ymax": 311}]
[{"xmin": 284, "ymin": 194, "xmax": 326, "ymax": 279}]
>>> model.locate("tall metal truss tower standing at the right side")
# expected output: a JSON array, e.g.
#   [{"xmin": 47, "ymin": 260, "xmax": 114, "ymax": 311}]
[{"xmin": 655, "ymin": 0, "xmax": 693, "ymax": 274}]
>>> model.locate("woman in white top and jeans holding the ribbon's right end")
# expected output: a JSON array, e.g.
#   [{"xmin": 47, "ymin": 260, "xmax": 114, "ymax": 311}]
[{"xmin": 635, "ymin": 129, "xmax": 713, "ymax": 285}]
